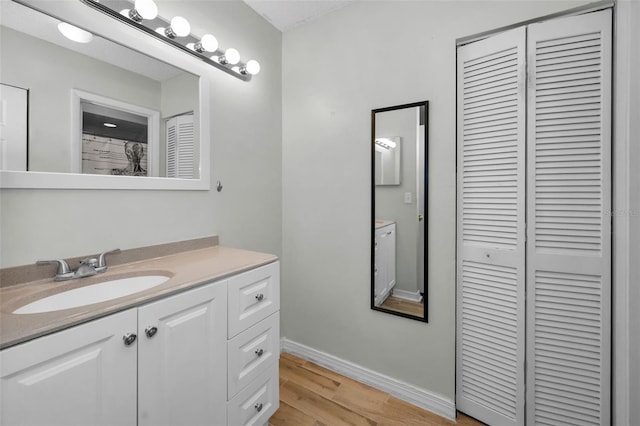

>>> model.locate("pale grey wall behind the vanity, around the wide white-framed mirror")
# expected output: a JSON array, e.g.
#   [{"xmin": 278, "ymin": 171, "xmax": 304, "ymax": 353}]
[{"xmin": 0, "ymin": 0, "xmax": 282, "ymax": 267}]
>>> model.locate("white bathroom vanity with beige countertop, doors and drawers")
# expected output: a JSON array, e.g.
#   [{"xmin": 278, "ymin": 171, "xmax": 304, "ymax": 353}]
[{"xmin": 0, "ymin": 246, "xmax": 280, "ymax": 426}]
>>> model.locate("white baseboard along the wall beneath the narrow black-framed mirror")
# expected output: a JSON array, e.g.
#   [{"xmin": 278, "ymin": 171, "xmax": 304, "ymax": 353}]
[{"xmin": 280, "ymin": 337, "xmax": 456, "ymax": 421}]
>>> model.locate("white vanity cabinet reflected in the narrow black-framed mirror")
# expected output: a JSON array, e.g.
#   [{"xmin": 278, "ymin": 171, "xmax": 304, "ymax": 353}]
[{"xmin": 373, "ymin": 223, "xmax": 396, "ymax": 306}]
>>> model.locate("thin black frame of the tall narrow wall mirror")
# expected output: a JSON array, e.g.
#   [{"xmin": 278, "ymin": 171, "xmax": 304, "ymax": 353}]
[{"xmin": 370, "ymin": 101, "xmax": 429, "ymax": 323}]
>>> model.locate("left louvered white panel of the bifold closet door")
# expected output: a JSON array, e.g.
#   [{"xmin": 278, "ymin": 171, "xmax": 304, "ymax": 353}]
[{"xmin": 456, "ymin": 28, "xmax": 525, "ymax": 425}]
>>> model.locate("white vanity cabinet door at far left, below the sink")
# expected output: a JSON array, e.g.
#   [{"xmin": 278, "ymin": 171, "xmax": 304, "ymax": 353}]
[{"xmin": 0, "ymin": 309, "xmax": 137, "ymax": 426}]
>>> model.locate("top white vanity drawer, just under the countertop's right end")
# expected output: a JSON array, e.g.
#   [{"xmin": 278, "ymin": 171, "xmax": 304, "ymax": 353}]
[{"xmin": 227, "ymin": 262, "xmax": 280, "ymax": 339}]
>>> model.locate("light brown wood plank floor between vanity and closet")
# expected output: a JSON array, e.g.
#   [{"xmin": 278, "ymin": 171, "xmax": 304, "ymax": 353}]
[{"xmin": 269, "ymin": 353, "xmax": 483, "ymax": 426}]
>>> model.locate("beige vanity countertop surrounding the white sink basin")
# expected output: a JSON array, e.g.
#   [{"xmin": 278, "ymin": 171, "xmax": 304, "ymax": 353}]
[{"xmin": 0, "ymin": 246, "xmax": 278, "ymax": 349}]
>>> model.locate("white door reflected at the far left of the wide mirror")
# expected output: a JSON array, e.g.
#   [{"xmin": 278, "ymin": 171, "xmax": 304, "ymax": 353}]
[{"xmin": 0, "ymin": 84, "xmax": 29, "ymax": 171}]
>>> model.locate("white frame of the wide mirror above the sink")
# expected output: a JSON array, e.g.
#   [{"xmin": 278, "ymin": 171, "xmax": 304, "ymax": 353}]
[{"xmin": 0, "ymin": 0, "xmax": 213, "ymax": 190}]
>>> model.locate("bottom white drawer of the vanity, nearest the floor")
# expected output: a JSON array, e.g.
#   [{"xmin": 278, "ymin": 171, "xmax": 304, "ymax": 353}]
[{"xmin": 227, "ymin": 360, "xmax": 280, "ymax": 426}]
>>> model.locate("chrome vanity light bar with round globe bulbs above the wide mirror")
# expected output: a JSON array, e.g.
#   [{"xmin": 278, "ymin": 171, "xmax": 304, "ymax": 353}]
[{"xmin": 81, "ymin": 0, "xmax": 260, "ymax": 81}]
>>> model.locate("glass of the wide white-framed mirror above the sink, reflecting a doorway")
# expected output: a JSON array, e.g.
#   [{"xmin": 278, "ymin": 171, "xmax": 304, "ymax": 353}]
[{"xmin": 0, "ymin": 0, "xmax": 200, "ymax": 179}]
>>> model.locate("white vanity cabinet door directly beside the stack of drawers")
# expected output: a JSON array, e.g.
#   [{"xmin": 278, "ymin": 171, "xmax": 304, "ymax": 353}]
[{"xmin": 138, "ymin": 282, "xmax": 227, "ymax": 426}]
